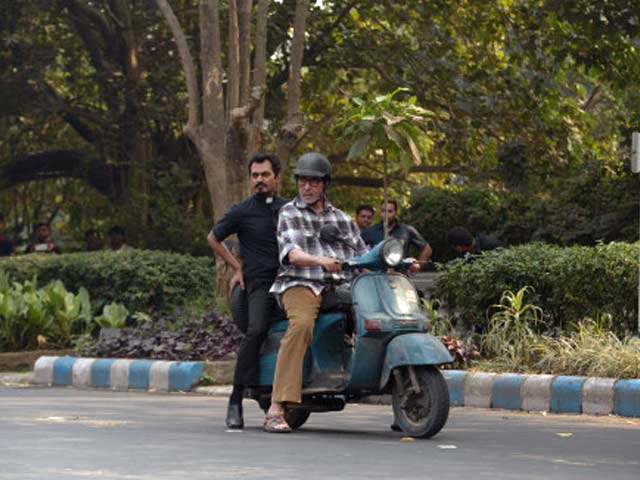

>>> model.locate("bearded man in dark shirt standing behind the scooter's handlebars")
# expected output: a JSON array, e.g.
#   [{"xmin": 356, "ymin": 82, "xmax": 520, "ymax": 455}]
[{"xmin": 361, "ymin": 199, "xmax": 431, "ymax": 262}]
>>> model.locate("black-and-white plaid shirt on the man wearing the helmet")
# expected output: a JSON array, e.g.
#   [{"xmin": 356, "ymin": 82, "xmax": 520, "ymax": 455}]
[{"xmin": 270, "ymin": 197, "xmax": 367, "ymax": 295}]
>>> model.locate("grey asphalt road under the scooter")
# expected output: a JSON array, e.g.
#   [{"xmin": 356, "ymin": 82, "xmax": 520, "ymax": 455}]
[{"xmin": 0, "ymin": 387, "xmax": 640, "ymax": 480}]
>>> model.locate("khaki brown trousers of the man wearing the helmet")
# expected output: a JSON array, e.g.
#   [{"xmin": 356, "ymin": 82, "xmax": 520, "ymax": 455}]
[{"xmin": 271, "ymin": 287, "xmax": 322, "ymax": 403}]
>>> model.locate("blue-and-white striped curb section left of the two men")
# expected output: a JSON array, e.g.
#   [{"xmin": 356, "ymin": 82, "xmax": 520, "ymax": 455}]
[{"xmin": 33, "ymin": 357, "xmax": 204, "ymax": 392}]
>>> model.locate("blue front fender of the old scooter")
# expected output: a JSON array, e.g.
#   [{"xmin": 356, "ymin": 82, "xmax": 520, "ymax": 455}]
[{"xmin": 380, "ymin": 333, "xmax": 453, "ymax": 390}]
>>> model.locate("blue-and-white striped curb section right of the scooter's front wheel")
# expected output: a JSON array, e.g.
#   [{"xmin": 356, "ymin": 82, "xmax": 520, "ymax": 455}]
[{"xmin": 442, "ymin": 370, "xmax": 640, "ymax": 417}]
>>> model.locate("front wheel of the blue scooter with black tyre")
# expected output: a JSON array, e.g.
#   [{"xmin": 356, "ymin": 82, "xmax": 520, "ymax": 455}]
[{"xmin": 392, "ymin": 365, "xmax": 449, "ymax": 438}]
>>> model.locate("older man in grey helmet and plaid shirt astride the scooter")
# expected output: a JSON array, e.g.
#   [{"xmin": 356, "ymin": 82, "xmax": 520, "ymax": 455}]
[{"xmin": 264, "ymin": 153, "xmax": 367, "ymax": 433}]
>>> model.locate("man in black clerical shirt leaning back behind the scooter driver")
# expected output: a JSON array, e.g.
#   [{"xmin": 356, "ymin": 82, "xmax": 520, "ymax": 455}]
[{"xmin": 207, "ymin": 153, "xmax": 286, "ymax": 429}]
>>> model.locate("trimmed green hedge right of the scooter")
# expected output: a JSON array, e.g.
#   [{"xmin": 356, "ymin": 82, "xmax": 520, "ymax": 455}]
[{"xmin": 436, "ymin": 243, "xmax": 640, "ymax": 332}]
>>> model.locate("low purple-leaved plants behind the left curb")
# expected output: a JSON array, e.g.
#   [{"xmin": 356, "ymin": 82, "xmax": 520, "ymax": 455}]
[{"xmin": 80, "ymin": 312, "xmax": 242, "ymax": 361}]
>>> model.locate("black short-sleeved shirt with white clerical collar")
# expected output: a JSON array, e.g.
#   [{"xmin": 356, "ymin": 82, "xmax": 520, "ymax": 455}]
[{"xmin": 211, "ymin": 193, "xmax": 287, "ymax": 283}]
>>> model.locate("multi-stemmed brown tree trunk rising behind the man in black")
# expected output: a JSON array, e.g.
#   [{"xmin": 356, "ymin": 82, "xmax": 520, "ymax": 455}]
[{"xmin": 156, "ymin": 0, "xmax": 309, "ymax": 218}]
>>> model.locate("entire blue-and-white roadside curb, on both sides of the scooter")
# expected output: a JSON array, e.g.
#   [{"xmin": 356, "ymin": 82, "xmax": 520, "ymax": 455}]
[{"xmin": 18, "ymin": 356, "xmax": 640, "ymax": 417}]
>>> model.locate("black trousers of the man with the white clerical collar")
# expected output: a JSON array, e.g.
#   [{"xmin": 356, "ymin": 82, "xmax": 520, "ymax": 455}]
[{"xmin": 233, "ymin": 283, "xmax": 282, "ymax": 385}]
